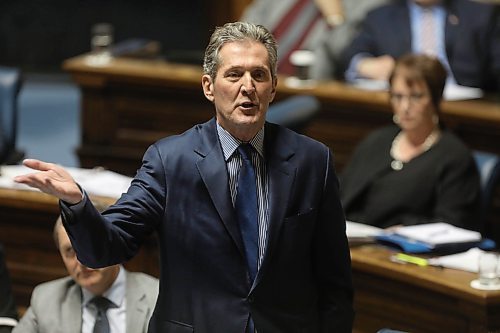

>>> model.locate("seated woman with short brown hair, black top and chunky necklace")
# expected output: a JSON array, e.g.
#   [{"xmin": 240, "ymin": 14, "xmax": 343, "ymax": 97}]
[{"xmin": 340, "ymin": 54, "xmax": 481, "ymax": 230}]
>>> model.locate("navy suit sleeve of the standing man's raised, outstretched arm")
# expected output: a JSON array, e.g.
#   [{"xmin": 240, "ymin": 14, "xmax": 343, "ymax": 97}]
[{"xmin": 61, "ymin": 145, "xmax": 166, "ymax": 268}]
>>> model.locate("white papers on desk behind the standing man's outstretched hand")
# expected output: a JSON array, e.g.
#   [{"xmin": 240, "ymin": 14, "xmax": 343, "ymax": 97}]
[{"xmin": 0, "ymin": 165, "xmax": 132, "ymax": 198}]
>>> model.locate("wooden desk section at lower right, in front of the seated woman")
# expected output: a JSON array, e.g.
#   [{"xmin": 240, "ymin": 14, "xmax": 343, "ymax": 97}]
[{"xmin": 351, "ymin": 245, "xmax": 500, "ymax": 333}]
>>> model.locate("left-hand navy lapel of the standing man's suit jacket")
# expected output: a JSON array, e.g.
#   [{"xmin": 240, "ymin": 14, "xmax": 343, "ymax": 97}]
[{"xmin": 195, "ymin": 119, "xmax": 245, "ymax": 256}]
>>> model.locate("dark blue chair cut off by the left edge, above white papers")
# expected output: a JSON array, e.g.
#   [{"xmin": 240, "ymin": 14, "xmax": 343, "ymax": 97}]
[{"xmin": 0, "ymin": 66, "xmax": 24, "ymax": 164}]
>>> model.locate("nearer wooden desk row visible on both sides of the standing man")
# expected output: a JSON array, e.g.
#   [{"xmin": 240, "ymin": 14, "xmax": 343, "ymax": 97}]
[{"xmin": 0, "ymin": 189, "xmax": 500, "ymax": 333}]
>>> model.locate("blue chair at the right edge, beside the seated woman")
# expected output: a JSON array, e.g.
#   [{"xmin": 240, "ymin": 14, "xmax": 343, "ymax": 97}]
[{"xmin": 473, "ymin": 151, "xmax": 500, "ymax": 243}]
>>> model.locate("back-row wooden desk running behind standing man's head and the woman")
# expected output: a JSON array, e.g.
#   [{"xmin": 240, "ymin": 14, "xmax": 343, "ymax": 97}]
[{"xmin": 63, "ymin": 55, "xmax": 500, "ymax": 175}]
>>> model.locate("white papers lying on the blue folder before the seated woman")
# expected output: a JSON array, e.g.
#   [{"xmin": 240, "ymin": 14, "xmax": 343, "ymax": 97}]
[{"xmin": 396, "ymin": 222, "xmax": 481, "ymax": 245}]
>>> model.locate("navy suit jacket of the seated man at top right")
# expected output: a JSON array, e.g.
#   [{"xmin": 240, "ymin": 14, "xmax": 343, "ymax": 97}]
[{"xmin": 342, "ymin": 0, "xmax": 500, "ymax": 91}]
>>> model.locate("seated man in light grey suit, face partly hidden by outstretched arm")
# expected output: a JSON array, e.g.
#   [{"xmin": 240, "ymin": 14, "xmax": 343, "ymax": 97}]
[{"xmin": 13, "ymin": 205, "xmax": 158, "ymax": 333}]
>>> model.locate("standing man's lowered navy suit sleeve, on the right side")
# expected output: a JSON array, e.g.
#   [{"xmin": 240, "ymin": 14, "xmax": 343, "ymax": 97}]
[{"xmin": 313, "ymin": 151, "xmax": 354, "ymax": 332}]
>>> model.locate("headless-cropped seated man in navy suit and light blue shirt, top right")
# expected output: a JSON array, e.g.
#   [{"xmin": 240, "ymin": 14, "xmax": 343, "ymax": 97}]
[{"xmin": 342, "ymin": 0, "xmax": 500, "ymax": 91}]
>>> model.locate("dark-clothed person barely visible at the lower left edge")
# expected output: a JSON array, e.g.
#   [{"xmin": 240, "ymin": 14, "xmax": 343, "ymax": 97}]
[{"xmin": 0, "ymin": 244, "xmax": 17, "ymax": 333}]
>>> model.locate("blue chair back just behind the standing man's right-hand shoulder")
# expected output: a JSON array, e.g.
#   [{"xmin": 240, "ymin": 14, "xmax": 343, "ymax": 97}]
[{"xmin": 266, "ymin": 95, "xmax": 320, "ymax": 133}]
